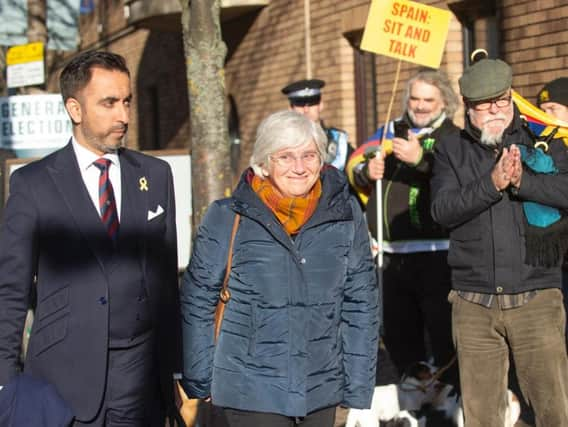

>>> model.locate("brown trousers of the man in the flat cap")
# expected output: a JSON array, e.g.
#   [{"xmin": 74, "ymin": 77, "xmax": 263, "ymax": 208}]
[{"xmin": 451, "ymin": 289, "xmax": 568, "ymax": 427}]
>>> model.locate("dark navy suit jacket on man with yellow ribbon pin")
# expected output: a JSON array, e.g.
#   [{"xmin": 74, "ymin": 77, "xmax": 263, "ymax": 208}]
[{"xmin": 0, "ymin": 143, "xmax": 181, "ymax": 420}]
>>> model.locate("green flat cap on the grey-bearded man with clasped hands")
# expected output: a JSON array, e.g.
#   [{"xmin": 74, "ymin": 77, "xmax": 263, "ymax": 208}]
[{"xmin": 459, "ymin": 58, "xmax": 513, "ymax": 101}]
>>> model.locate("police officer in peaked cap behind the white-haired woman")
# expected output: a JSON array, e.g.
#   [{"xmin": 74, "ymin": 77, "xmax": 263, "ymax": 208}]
[{"xmin": 282, "ymin": 79, "xmax": 353, "ymax": 170}]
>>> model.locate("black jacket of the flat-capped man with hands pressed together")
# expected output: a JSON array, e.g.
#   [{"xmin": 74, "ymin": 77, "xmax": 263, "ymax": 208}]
[{"xmin": 431, "ymin": 108, "xmax": 568, "ymax": 294}]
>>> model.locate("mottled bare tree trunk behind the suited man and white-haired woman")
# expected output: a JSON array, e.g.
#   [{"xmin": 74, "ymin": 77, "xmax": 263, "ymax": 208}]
[{"xmin": 180, "ymin": 0, "xmax": 231, "ymax": 231}]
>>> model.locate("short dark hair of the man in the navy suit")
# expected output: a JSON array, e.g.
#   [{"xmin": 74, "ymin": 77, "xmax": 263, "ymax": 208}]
[{"xmin": 59, "ymin": 50, "xmax": 130, "ymax": 102}]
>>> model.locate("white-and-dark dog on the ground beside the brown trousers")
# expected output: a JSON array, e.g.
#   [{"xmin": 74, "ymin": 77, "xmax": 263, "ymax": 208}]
[{"xmin": 345, "ymin": 362, "xmax": 521, "ymax": 427}]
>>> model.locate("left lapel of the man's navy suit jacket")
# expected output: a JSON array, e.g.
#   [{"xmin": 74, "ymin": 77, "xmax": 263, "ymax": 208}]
[{"xmin": 48, "ymin": 143, "xmax": 113, "ymax": 269}]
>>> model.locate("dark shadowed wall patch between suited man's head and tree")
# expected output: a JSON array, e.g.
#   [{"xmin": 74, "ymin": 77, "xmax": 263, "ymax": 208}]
[{"xmin": 136, "ymin": 31, "xmax": 190, "ymax": 150}]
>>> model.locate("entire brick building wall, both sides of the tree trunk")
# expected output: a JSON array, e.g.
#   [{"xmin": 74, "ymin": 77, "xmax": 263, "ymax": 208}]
[{"xmin": 45, "ymin": 0, "xmax": 568, "ymax": 169}]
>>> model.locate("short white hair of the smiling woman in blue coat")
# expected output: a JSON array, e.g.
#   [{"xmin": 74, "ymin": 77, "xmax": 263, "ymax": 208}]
[{"xmin": 250, "ymin": 110, "xmax": 327, "ymax": 178}]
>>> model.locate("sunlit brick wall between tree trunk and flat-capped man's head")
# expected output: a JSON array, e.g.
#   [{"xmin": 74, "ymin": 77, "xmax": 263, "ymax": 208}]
[{"xmin": 222, "ymin": 0, "xmax": 463, "ymax": 167}]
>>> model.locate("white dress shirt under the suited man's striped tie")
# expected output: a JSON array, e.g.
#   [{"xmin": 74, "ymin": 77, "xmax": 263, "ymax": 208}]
[{"xmin": 72, "ymin": 137, "xmax": 122, "ymax": 221}]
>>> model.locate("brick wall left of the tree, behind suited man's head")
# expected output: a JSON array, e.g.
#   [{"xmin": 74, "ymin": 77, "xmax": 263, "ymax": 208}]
[{"xmin": 49, "ymin": 0, "xmax": 190, "ymax": 150}]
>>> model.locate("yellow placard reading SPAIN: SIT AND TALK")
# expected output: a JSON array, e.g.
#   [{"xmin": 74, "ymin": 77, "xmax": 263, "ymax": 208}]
[{"xmin": 361, "ymin": 0, "xmax": 451, "ymax": 68}]
